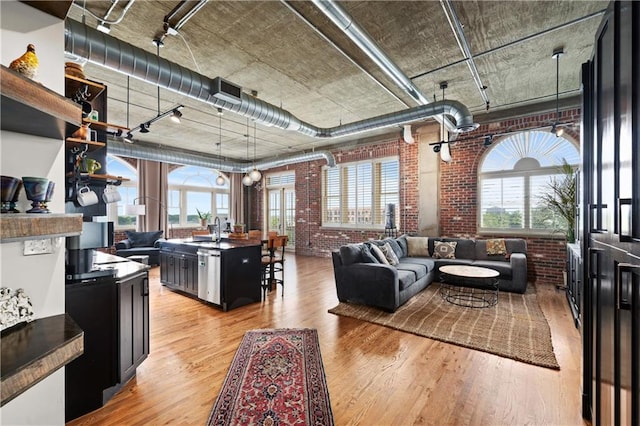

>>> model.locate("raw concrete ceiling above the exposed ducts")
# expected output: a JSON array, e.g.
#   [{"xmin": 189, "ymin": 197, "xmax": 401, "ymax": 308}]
[{"xmin": 62, "ymin": 0, "xmax": 608, "ymax": 161}]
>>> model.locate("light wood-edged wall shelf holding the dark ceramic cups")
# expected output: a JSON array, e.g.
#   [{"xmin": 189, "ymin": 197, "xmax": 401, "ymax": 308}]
[{"xmin": 0, "ymin": 213, "xmax": 82, "ymax": 243}]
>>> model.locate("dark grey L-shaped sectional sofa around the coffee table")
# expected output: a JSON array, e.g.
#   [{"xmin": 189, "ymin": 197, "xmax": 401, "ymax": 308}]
[{"xmin": 332, "ymin": 235, "xmax": 527, "ymax": 312}]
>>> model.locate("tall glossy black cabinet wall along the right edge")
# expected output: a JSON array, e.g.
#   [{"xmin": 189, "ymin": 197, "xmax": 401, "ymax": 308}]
[{"xmin": 582, "ymin": 1, "xmax": 640, "ymax": 426}]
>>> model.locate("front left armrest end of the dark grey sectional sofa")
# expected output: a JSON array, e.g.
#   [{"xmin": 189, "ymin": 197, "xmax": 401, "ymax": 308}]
[{"xmin": 335, "ymin": 263, "xmax": 400, "ymax": 312}]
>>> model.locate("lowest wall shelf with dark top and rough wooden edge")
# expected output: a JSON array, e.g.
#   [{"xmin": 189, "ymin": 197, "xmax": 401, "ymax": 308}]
[{"xmin": 0, "ymin": 314, "xmax": 84, "ymax": 406}]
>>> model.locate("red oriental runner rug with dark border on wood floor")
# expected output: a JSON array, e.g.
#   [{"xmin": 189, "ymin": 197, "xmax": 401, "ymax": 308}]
[{"xmin": 207, "ymin": 329, "xmax": 333, "ymax": 426}]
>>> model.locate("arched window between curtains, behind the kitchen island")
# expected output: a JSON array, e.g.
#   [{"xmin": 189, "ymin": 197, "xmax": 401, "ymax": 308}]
[{"xmin": 168, "ymin": 166, "xmax": 229, "ymax": 226}]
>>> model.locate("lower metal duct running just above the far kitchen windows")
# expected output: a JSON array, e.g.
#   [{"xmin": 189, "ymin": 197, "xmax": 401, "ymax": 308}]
[{"xmin": 107, "ymin": 139, "xmax": 336, "ymax": 173}]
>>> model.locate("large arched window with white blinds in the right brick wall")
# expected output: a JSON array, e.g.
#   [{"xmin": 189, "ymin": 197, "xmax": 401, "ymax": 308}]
[{"xmin": 478, "ymin": 131, "xmax": 580, "ymax": 234}]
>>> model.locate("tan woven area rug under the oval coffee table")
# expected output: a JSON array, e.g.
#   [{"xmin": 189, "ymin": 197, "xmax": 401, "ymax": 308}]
[{"xmin": 329, "ymin": 283, "xmax": 560, "ymax": 369}]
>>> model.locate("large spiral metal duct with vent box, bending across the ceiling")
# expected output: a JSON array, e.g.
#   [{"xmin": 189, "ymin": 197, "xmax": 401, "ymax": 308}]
[{"xmin": 65, "ymin": 19, "xmax": 477, "ymax": 142}]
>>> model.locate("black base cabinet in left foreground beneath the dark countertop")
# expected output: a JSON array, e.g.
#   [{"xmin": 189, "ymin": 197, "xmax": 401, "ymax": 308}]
[{"xmin": 65, "ymin": 271, "xmax": 149, "ymax": 421}]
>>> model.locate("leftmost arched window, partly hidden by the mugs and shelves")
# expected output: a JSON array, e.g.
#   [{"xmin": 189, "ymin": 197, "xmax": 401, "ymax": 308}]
[{"xmin": 107, "ymin": 155, "xmax": 138, "ymax": 229}]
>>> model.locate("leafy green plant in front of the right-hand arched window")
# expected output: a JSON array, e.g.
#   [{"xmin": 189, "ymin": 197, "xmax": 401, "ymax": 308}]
[{"xmin": 540, "ymin": 159, "xmax": 576, "ymax": 243}]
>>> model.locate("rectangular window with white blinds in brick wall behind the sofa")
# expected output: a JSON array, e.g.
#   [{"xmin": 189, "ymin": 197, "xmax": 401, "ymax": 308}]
[{"xmin": 322, "ymin": 158, "xmax": 400, "ymax": 229}]
